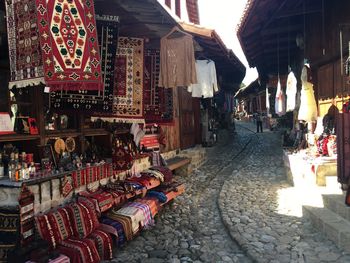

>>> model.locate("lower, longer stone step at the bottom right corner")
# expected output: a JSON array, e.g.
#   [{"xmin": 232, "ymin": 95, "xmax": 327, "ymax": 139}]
[{"xmin": 303, "ymin": 206, "xmax": 350, "ymax": 252}]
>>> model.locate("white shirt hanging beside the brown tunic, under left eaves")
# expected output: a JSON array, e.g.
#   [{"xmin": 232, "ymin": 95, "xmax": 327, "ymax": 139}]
[{"xmin": 187, "ymin": 60, "xmax": 219, "ymax": 98}]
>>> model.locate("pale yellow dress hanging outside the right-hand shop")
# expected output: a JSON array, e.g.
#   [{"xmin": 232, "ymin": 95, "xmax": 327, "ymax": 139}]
[{"xmin": 298, "ymin": 66, "xmax": 317, "ymax": 122}]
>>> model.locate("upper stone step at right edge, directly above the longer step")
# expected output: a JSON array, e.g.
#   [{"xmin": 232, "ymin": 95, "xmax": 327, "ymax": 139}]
[{"xmin": 322, "ymin": 194, "xmax": 350, "ymax": 222}]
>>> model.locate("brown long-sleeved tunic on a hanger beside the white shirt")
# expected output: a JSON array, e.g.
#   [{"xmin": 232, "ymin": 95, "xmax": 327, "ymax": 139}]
[{"xmin": 158, "ymin": 27, "xmax": 197, "ymax": 88}]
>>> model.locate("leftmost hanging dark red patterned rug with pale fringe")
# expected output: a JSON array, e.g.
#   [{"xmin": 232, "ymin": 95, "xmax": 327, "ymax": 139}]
[{"xmin": 5, "ymin": 0, "xmax": 44, "ymax": 88}]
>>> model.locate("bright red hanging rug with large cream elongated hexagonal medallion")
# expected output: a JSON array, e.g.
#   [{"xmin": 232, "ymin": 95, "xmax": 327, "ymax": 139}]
[{"xmin": 35, "ymin": 0, "xmax": 102, "ymax": 90}]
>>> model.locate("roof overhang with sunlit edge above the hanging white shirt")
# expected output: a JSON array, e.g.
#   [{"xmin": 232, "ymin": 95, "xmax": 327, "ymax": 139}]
[{"xmin": 180, "ymin": 23, "xmax": 246, "ymax": 92}]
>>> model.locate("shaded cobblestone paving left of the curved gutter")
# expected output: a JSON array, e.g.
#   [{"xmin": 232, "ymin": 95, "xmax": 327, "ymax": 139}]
[{"xmin": 108, "ymin": 124, "xmax": 252, "ymax": 263}]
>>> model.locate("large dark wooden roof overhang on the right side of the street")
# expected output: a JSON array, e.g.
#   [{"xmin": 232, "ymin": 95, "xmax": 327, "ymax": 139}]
[{"xmin": 237, "ymin": 0, "xmax": 322, "ymax": 76}]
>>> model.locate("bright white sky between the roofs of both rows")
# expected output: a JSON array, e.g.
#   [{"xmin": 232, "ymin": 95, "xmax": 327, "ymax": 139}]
[{"xmin": 198, "ymin": 0, "xmax": 258, "ymax": 85}]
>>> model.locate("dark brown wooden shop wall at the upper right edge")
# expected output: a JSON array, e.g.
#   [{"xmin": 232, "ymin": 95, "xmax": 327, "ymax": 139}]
[{"xmin": 304, "ymin": 0, "xmax": 350, "ymax": 116}]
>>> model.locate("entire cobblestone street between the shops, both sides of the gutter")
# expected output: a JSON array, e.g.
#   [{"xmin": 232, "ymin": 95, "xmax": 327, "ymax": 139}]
[{"xmin": 112, "ymin": 123, "xmax": 350, "ymax": 263}]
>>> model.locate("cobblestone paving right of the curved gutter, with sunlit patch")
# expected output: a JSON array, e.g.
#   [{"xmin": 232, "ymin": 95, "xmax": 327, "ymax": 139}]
[{"xmin": 219, "ymin": 124, "xmax": 350, "ymax": 263}]
